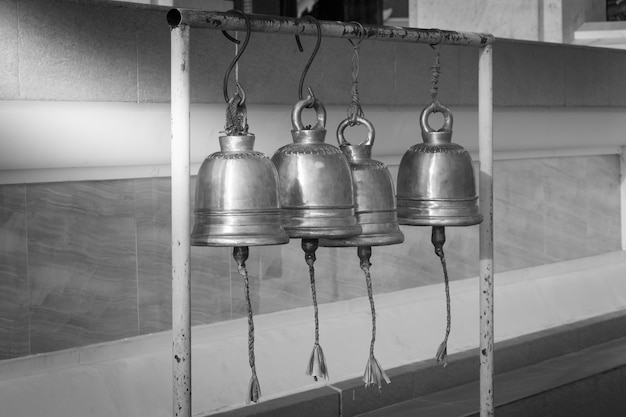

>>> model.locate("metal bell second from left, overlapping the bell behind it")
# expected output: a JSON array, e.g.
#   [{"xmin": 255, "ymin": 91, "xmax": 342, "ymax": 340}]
[{"xmin": 272, "ymin": 95, "xmax": 361, "ymax": 239}]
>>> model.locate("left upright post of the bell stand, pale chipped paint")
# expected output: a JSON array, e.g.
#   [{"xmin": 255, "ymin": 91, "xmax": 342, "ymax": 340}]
[{"xmin": 171, "ymin": 24, "xmax": 191, "ymax": 417}]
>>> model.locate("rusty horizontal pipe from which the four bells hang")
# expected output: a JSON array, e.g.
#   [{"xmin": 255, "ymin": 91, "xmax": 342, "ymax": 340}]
[{"xmin": 167, "ymin": 9, "xmax": 495, "ymax": 47}]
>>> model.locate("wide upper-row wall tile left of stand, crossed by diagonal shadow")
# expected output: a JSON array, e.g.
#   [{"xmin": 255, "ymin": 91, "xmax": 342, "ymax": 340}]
[{"xmin": 18, "ymin": 0, "xmax": 137, "ymax": 101}]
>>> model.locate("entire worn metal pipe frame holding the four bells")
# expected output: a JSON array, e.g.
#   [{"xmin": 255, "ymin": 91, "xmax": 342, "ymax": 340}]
[{"xmin": 167, "ymin": 9, "xmax": 495, "ymax": 417}]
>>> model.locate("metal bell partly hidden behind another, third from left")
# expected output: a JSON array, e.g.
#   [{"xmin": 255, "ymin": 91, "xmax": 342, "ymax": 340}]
[{"xmin": 320, "ymin": 117, "xmax": 404, "ymax": 247}]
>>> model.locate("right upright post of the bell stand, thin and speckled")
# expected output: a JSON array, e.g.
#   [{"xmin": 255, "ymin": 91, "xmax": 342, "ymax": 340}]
[{"xmin": 478, "ymin": 45, "xmax": 494, "ymax": 417}]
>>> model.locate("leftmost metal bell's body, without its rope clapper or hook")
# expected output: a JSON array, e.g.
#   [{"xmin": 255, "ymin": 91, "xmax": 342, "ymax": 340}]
[{"xmin": 191, "ymin": 134, "xmax": 289, "ymax": 246}]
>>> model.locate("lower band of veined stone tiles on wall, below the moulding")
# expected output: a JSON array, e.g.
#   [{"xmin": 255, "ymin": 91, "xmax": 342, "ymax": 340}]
[{"xmin": 0, "ymin": 155, "xmax": 620, "ymax": 359}]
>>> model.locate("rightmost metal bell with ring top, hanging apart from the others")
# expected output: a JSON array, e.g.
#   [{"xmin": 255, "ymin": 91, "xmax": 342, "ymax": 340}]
[{"xmin": 397, "ymin": 103, "xmax": 483, "ymax": 226}]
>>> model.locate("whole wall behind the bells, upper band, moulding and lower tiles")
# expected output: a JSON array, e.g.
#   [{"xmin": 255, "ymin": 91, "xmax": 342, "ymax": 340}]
[{"xmin": 0, "ymin": 0, "xmax": 626, "ymax": 358}]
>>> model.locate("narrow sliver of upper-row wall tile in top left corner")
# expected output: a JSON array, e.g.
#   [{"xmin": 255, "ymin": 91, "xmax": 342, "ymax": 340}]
[{"xmin": 0, "ymin": 0, "xmax": 20, "ymax": 100}]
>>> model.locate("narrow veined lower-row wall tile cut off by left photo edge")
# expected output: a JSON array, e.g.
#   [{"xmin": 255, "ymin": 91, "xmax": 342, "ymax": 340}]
[{"xmin": 0, "ymin": 185, "xmax": 30, "ymax": 360}]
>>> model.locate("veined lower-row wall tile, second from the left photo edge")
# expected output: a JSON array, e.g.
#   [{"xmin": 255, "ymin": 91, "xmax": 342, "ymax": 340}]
[{"xmin": 26, "ymin": 181, "xmax": 138, "ymax": 353}]
